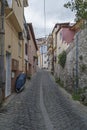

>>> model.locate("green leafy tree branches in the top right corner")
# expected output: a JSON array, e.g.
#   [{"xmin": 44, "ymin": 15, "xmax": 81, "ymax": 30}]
[{"xmin": 64, "ymin": 0, "xmax": 87, "ymax": 21}]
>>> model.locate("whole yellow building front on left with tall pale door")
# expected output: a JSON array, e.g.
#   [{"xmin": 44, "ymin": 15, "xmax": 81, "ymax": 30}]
[{"xmin": 3, "ymin": 0, "xmax": 28, "ymax": 98}]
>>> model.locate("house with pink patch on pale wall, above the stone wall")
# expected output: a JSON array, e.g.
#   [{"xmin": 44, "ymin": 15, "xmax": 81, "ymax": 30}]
[{"xmin": 52, "ymin": 23, "xmax": 76, "ymax": 75}]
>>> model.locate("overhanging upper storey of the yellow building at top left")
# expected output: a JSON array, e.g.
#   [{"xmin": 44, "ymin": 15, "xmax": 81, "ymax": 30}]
[{"xmin": 5, "ymin": 0, "xmax": 27, "ymax": 32}]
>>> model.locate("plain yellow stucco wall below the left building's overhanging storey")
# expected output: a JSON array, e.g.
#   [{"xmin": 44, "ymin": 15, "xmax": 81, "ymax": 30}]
[{"xmin": 5, "ymin": 20, "xmax": 23, "ymax": 71}]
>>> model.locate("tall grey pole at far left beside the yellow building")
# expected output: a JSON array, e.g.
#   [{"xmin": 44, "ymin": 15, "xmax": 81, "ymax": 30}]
[{"xmin": 0, "ymin": 0, "xmax": 5, "ymax": 97}]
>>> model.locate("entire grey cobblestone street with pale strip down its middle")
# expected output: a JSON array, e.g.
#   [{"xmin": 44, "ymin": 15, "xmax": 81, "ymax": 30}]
[{"xmin": 0, "ymin": 71, "xmax": 87, "ymax": 130}]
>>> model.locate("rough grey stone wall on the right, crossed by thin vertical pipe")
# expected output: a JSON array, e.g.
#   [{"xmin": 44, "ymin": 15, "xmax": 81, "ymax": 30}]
[{"xmin": 55, "ymin": 29, "xmax": 87, "ymax": 89}]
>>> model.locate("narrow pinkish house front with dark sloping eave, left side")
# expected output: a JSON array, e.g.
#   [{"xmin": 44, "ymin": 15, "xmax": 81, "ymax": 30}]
[{"xmin": 28, "ymin": 23, "xmax": 38, "ymax": 75}]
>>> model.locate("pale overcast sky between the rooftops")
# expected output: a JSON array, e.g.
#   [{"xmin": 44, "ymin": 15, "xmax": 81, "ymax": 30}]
[{"xmin": 25, "ymin": 0, "xmax": 75, "ymax": 38}]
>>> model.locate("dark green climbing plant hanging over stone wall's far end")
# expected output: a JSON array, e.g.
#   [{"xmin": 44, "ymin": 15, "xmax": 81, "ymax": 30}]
[{"xmin": 58, "ymin": 51, "xmax": 66, "ymax": 68}]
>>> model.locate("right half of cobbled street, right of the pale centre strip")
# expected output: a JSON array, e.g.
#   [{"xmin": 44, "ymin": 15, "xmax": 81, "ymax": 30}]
[{"xmin": 42, "ymin": 72, "xmax": 87, "ymax": 130}]
